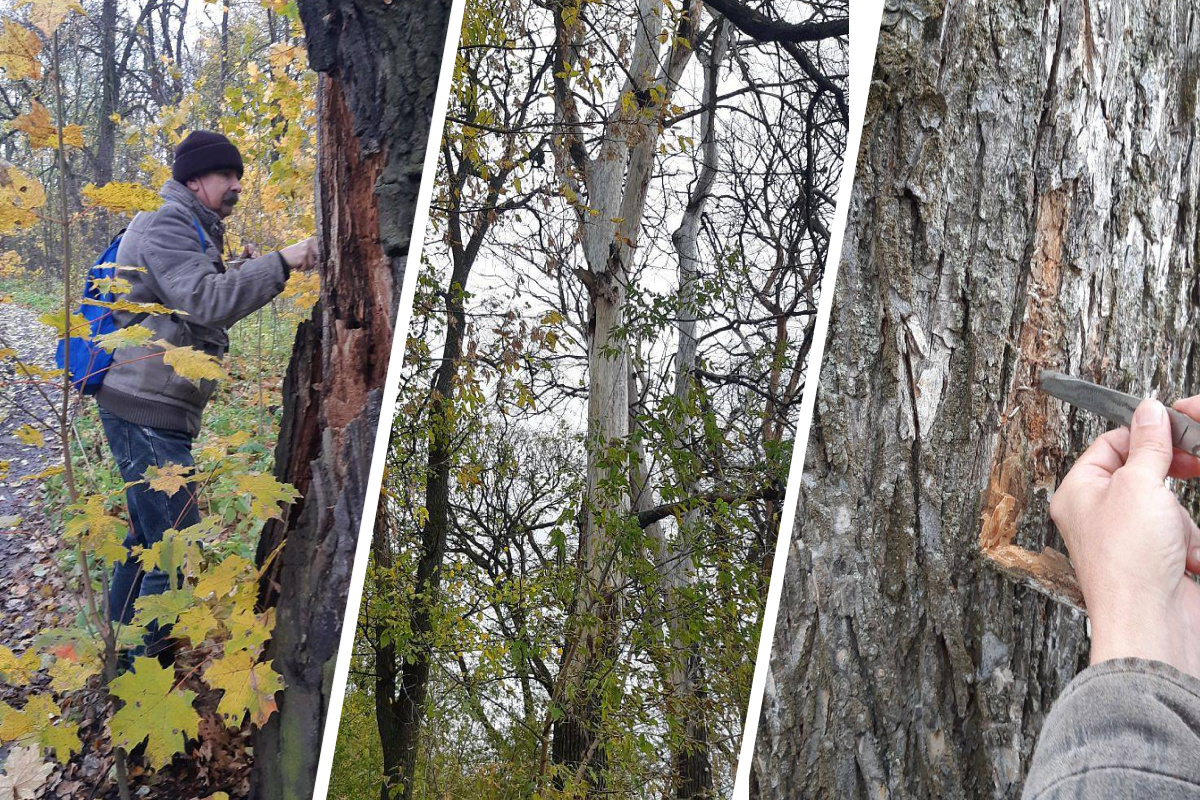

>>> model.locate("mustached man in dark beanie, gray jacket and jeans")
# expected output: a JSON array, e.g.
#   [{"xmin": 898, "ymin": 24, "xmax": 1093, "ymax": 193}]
[{"xmin": 96, "ymin": 131, "xmax": 316, "ymax": 662}]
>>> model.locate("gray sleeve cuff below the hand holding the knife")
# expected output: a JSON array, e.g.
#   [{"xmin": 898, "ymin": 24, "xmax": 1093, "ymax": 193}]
[{"xmin": 1022, "ymin": 658, "xmax": 1200, "ymax": 800}]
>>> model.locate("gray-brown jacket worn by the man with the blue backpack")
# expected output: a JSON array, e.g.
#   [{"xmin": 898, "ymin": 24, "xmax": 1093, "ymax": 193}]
[{"xmin": 96, "ymin": 180, "xmax": 288, "ymax": 437}]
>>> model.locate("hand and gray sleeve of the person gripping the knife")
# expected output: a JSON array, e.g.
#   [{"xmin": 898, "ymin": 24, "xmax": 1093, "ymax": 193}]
[{"xmin": 1024, "ymin": 396, "xmax": 1200, "ymax": 800}]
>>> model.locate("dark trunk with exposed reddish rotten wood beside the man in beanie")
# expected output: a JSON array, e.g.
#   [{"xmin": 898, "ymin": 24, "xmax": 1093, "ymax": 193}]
[{"xmin": 252, "ymin": 0, "xmax": 450, "ymax": 800}]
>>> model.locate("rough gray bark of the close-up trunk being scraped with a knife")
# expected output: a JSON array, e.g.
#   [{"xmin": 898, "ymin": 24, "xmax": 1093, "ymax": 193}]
[{"xmin": 751, "ymin": 0, "xmax": 1200, "ymax": 798}]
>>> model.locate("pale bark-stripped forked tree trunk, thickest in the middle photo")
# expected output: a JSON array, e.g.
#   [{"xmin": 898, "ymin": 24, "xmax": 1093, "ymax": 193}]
[{"xmin": 551, "ymin": 0, "xmax": 703, "ymax": 792}]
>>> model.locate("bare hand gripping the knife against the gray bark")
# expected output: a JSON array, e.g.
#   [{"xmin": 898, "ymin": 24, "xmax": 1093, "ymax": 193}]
[{"xmin": 1050, "ymin": 396, "xmax": 1200, "ymax": 678}]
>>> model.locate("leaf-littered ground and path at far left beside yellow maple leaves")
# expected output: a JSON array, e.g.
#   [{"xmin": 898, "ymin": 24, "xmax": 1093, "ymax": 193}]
[{"xmin": 0, "ymin": 302, "xmax": 251, "ymax": 800}]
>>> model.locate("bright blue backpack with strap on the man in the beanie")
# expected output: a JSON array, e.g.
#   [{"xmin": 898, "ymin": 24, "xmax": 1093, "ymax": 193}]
[{"xmin": 54, "ymin": 217, "xmax": 204, "ymax": 395}]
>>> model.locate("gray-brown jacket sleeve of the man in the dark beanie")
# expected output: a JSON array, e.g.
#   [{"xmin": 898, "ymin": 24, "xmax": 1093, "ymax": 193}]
[{"xmin": 142, "ymin": 203, "xmax": 287, "ymax": 327}]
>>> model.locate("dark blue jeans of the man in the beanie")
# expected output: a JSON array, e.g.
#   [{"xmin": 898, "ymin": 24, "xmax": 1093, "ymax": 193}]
[{"xmin": 100, "ymin": 408, "xmax": 200, "ymax": 655}]
